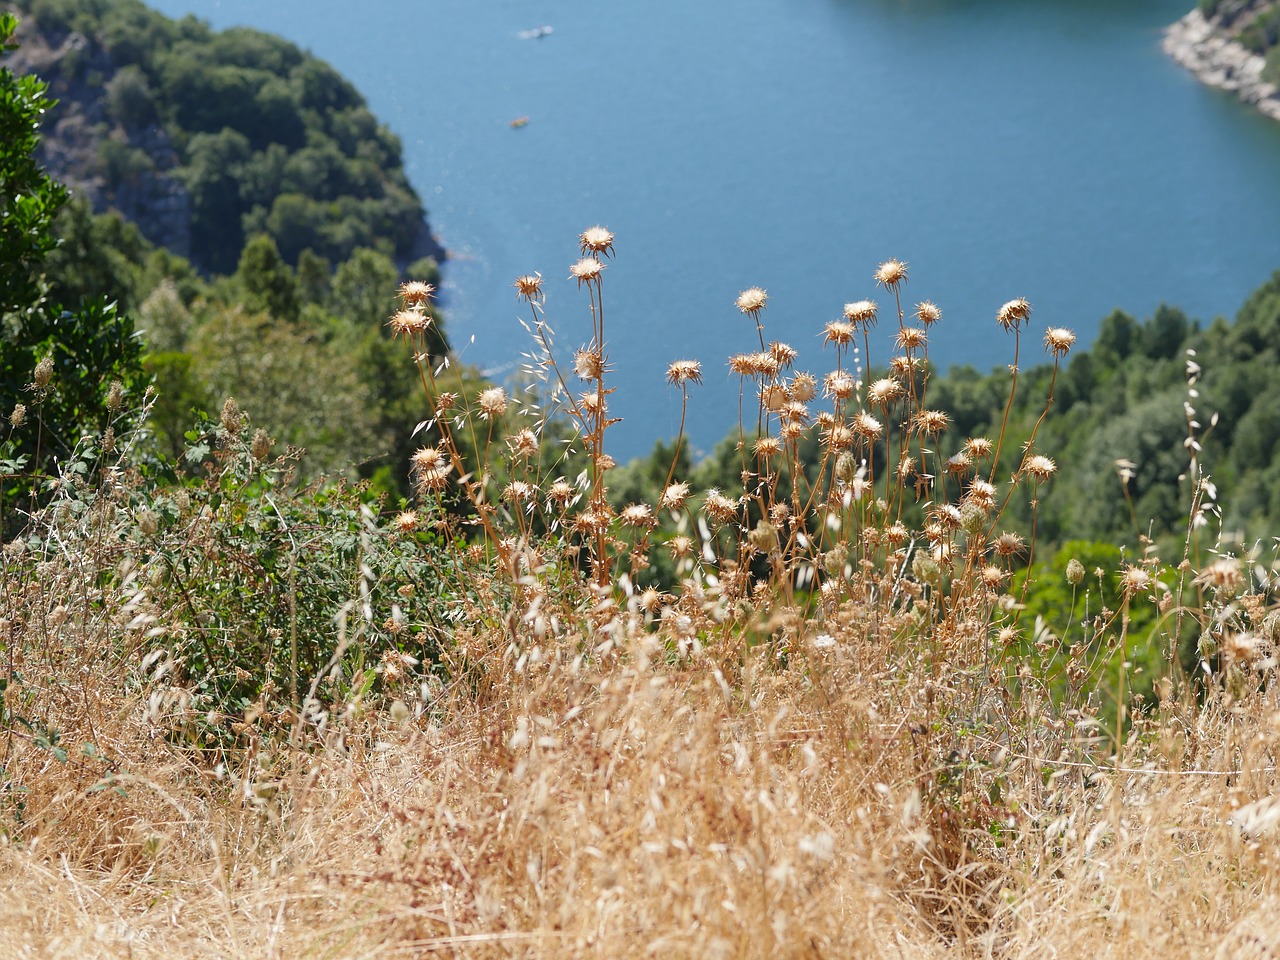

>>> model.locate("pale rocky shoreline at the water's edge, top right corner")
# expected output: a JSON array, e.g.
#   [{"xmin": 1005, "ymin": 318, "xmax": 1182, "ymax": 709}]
[{"xmin": 1164, "ymin": 0, "xmax": 1280, "ymax": 120}]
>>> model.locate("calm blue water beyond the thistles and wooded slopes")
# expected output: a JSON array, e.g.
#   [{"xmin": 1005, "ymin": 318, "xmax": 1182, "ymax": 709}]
[{"xmin": 145, "ymin": 0, "xmax": 1280, "ymax": 460}]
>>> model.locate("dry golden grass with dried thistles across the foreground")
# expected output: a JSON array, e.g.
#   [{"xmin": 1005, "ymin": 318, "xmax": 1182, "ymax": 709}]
[{"xmin": 0, "ymin": 228, "xmax": 1280, "ymax": 960}]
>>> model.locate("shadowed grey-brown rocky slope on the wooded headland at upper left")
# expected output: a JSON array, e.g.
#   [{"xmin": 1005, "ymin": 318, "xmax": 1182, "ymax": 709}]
[{"xmin": 8, "ymin": 29, "xmax": 192, "ymax": 257}]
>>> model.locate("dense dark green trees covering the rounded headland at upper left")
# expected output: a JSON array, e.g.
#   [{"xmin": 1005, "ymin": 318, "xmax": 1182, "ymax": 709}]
[{"xmin": 8, "ymin": 0, "xmax": 433, "ymax": 274}]
